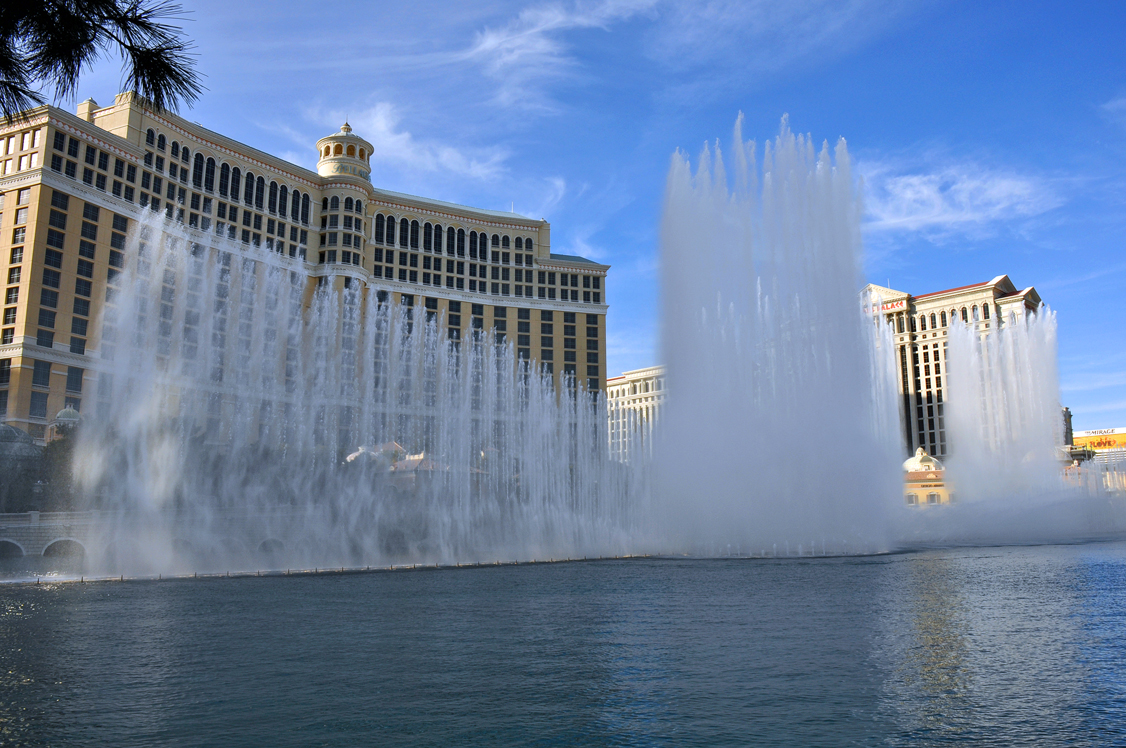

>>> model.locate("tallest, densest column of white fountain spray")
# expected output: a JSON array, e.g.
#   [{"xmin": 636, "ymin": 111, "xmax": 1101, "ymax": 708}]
[{"xmin": 654, "ymin": 116, "xmax": 902, "ymax": 555}]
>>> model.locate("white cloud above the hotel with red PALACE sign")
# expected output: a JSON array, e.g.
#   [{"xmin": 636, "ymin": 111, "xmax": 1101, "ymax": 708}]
[{"xmin": 858, "ymin": 162, "xmax": 1063, "ymax": 237}]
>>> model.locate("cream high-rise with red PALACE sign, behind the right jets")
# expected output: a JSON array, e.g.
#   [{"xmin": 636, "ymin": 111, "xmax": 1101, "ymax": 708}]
[{"xmin": 861, "ymin": 275, "xmax": 1040, "ymax": 456}]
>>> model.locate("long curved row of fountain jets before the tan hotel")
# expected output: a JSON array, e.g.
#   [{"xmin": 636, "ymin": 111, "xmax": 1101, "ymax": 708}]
[{"xmin": 70, "ymin": 216, "xmax": 631, "ymax": 572}]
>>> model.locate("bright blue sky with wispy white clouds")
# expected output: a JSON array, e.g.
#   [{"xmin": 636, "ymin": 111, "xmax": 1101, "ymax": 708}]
[{"xmin": 68, "ymin": 0, "xmax": 1126, "ymax": 429}]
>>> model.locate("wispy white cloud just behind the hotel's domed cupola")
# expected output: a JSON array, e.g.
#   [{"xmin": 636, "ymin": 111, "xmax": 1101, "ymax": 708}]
[{"xmin": 312, "ymin": 101, "xmax": 509, "ymax": 180}]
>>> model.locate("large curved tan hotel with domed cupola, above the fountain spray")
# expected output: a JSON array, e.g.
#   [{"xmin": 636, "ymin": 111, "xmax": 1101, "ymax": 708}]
[{"xmin": 0, "ymin": 94, "xmax": 609, "ymax": 440}]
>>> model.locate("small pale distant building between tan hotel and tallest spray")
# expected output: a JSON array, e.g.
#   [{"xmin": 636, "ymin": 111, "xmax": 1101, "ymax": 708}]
[{"xmin": 606, "ymin": 366, "xmax": 668, "ymax": 462}]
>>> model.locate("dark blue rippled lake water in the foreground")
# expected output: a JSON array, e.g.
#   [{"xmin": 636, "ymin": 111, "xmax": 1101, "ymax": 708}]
[{"xmin": 0, "ymin": 544, "xmax": 1126, "ymax": 746}]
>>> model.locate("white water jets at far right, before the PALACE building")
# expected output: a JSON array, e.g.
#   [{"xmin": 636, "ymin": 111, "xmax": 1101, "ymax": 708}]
[{"xmin": 899, "ymin": 306, "xmax": 1126, "ymax": 546}]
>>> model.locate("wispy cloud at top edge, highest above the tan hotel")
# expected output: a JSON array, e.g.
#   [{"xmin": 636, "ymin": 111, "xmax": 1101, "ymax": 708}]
[{"xmin": 458, "ymin": 0, "xmax": 656, "ymax": 109}]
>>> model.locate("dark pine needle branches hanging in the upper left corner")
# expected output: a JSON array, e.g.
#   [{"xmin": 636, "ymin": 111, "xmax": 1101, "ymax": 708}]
[{"xmin": 0, "ymin": 0, "xmax": 203, "ymax": 122}]
